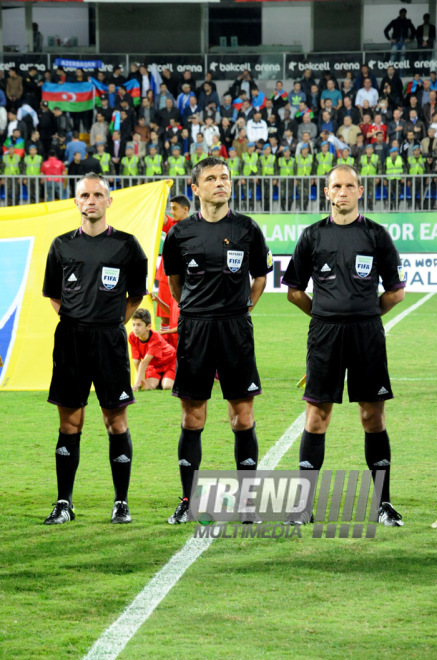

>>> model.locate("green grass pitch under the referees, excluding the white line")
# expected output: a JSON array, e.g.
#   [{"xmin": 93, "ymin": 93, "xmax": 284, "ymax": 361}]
[{"xmin": 0, "ymin": 294, "xmax": 437, "ymax": 660}]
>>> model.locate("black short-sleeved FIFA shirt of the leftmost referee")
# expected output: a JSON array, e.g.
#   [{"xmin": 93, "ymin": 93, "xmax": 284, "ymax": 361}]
[{"xmin": 43, "ymin": 227, "xmax": 147, "ymax": 326}]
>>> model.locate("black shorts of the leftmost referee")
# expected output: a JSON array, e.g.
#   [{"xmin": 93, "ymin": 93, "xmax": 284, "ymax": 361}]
[{"xmin": 48, "ymin": 321, "xmax": 135, "ymax": 409}]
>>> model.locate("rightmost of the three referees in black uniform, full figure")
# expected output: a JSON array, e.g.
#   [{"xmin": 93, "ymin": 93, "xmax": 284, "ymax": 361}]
[{"xmin": 283, "ymin": 165, "xmax": 405, "ymax": 527}]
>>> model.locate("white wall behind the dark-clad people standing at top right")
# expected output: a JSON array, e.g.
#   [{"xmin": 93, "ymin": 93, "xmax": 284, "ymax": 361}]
[{"xmin": 362, "ymin": 0, "xmax": 435, "ymax": 47}]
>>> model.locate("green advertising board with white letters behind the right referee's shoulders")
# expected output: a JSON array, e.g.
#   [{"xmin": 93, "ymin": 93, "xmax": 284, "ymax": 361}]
[{"xmin": 252, "ymin": 213, "xmax": 437, "ymax": 254}]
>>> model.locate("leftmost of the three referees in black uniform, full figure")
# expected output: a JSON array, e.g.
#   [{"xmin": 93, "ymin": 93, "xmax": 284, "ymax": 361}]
[{"xmin": 43, "ymin": 172, "xmax": 147, "ymax": 525}]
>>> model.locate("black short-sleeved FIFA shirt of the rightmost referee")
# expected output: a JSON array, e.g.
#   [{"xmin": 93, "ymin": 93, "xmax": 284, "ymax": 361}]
[{"xmin": 282, "ymin": 215, "xmax": 405, "ymax": 321}]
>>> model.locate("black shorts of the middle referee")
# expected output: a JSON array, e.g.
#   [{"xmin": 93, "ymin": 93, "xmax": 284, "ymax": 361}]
[{"xmin": 173, "ymin": 314, "xmax": 261, "ymax": 401}]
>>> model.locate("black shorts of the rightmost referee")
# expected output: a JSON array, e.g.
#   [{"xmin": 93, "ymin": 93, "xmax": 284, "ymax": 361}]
[{"xmin": 303, "ymin": 318, "xmax": 393, "ymax": 403}]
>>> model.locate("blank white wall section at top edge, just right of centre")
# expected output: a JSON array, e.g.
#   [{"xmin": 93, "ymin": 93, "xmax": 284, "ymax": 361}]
[{"xmin": 262, "ymin": 2, "xmax": 313, "ymax": 52}]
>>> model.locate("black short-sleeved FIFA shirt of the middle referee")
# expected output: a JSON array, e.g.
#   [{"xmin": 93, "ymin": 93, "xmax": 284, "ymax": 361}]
[{"xmin": 162, "ymin": 211, "xmax": 272, "ymax": 317}]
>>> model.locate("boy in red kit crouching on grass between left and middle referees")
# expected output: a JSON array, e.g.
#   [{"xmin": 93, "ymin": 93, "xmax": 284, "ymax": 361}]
[{"xmin": 129, "ymin": 307, "xmax": 176, "ymax": 392}]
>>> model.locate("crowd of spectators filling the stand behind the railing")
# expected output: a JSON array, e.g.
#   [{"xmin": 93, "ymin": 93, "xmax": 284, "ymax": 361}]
[{"xmin": 0, "ymin": 63, "xmax": 437, "ymax": 211}]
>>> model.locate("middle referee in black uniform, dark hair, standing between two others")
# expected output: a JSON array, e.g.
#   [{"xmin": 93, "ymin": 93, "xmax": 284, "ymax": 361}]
[{"xmin": 163, "ymin": 158, "xmax": 272, "ymax": 524}]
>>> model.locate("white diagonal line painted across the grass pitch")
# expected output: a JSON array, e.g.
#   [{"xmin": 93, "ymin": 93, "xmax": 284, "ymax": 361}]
[{"xmin": 84, "ymin": 293, "xmax": 433, "ymax": 660}]
